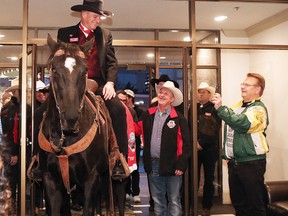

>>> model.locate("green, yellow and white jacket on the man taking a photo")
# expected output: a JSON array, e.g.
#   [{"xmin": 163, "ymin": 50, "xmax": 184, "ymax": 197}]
[{"xmin": 217, "ymin": 98, "xmax": 269, "ymax": 162}]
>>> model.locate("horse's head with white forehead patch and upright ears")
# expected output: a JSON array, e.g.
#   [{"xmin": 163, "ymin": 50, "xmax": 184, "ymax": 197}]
[{"xmin": 47, "ymin": 35, "xmax": 94, "ymax": 133}]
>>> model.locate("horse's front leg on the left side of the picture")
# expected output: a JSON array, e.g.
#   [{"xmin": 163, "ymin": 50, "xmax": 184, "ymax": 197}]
[{"xmin": 43, "ymin": 172, "xmax": 71, "ymax": 216}]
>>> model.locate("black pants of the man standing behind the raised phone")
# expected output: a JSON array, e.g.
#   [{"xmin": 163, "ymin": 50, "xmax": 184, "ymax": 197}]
[{"xmin": 198, "ymin": 148, "xmax": 218, "ymax": 209}]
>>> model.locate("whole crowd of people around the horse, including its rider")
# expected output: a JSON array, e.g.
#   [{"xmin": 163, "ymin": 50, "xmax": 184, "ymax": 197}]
[{"xmin": 1, "ymin": 0, "xmax": 269, "ymax": 216}]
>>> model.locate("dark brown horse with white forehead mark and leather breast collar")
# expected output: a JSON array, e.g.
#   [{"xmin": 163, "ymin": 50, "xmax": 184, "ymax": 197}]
[{"xmin": 38, "ymin": 35, "xmax": 117, "ymax": 216}]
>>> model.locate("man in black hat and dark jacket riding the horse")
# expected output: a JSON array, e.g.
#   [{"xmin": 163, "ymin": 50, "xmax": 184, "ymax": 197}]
[{"xmin": 57, "ymin": 0, "xmax": 128, "ymax": 215}]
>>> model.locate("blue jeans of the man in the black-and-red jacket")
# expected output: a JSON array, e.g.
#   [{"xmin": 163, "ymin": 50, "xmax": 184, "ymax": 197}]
[{"xmin": 149, "ymin": 160, "xmax": 182, "ymax": 216}]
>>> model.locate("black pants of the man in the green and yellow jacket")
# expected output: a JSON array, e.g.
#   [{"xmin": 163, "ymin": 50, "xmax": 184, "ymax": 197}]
[{"xmin": 228, "ymin": 159, "xmax": 266, "ymax": 216}]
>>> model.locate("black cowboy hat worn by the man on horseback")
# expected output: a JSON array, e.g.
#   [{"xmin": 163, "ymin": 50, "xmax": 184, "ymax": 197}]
[{"xmin": 71, "ymin": 0, "xmax": 112, "ymax": 16}]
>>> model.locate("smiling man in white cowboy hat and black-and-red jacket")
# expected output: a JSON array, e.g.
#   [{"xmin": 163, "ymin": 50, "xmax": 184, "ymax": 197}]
[{"xmin": 135, "ymin": 81, "xmax": 190, "ymax": 216}]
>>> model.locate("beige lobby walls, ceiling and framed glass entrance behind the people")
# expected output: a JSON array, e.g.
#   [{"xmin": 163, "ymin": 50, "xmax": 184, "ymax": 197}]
[{"xmin": 0, "ymin": 0, "xmax": 288, "ymax": 216}]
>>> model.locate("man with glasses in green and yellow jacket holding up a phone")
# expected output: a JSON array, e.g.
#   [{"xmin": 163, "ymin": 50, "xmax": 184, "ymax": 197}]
[{"xmin": 212, "ymin": 73, "xmax": 269, "ymax": 216}]
